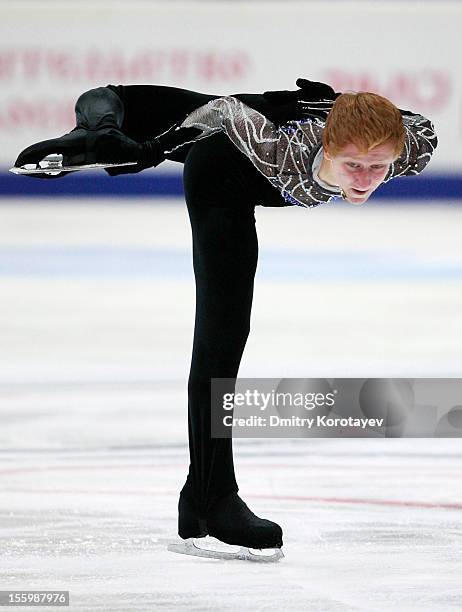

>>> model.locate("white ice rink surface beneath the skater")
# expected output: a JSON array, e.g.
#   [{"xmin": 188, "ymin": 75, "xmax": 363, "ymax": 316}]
[{"xmin": 0, "ymin": 200, "xmax": 462, "ymax": 612}]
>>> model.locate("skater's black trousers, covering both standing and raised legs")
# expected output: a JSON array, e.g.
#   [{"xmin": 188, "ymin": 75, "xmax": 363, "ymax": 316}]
[{"xmin": 72, "ymin": 85, "xmax": 286, "ymax": 516}]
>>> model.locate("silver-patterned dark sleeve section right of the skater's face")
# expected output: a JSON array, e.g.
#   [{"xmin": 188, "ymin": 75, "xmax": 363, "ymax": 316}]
[{"xmin": 385, "ymin": 115, "xmax": 438, "ymax": 182}]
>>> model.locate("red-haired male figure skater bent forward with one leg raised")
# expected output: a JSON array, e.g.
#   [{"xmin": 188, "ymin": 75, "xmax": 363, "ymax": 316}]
[{"xmin": 16, "ymin": 79, "xmax": 437, "ymax": 560}]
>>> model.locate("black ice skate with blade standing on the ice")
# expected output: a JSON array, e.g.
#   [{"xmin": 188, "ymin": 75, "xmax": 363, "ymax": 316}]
[{"xmin": 168, "ymin": 493, "xmax": 284, "ymax": 563}]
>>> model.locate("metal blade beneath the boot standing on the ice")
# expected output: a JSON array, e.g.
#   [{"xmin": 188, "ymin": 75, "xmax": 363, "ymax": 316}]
[{"xmin": 167, "ymin": 537, "xmax": 284, "ymax": 563}]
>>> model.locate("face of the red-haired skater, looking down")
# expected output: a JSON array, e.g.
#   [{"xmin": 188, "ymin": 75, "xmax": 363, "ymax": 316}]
[{"xmin": 324, "ymin": 143, "xmax": 396, "ymax": 204}]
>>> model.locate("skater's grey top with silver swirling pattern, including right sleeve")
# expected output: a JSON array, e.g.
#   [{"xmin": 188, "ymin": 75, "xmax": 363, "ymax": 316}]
[{"xmin": 182, "ymin": 96, "xmax": 437, "ymax": 208}]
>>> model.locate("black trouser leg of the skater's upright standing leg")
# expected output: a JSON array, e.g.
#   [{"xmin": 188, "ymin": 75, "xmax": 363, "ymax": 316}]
[{"xmin": 182, "ymin": 135, "xmax": 258, "ymax": 517}]
